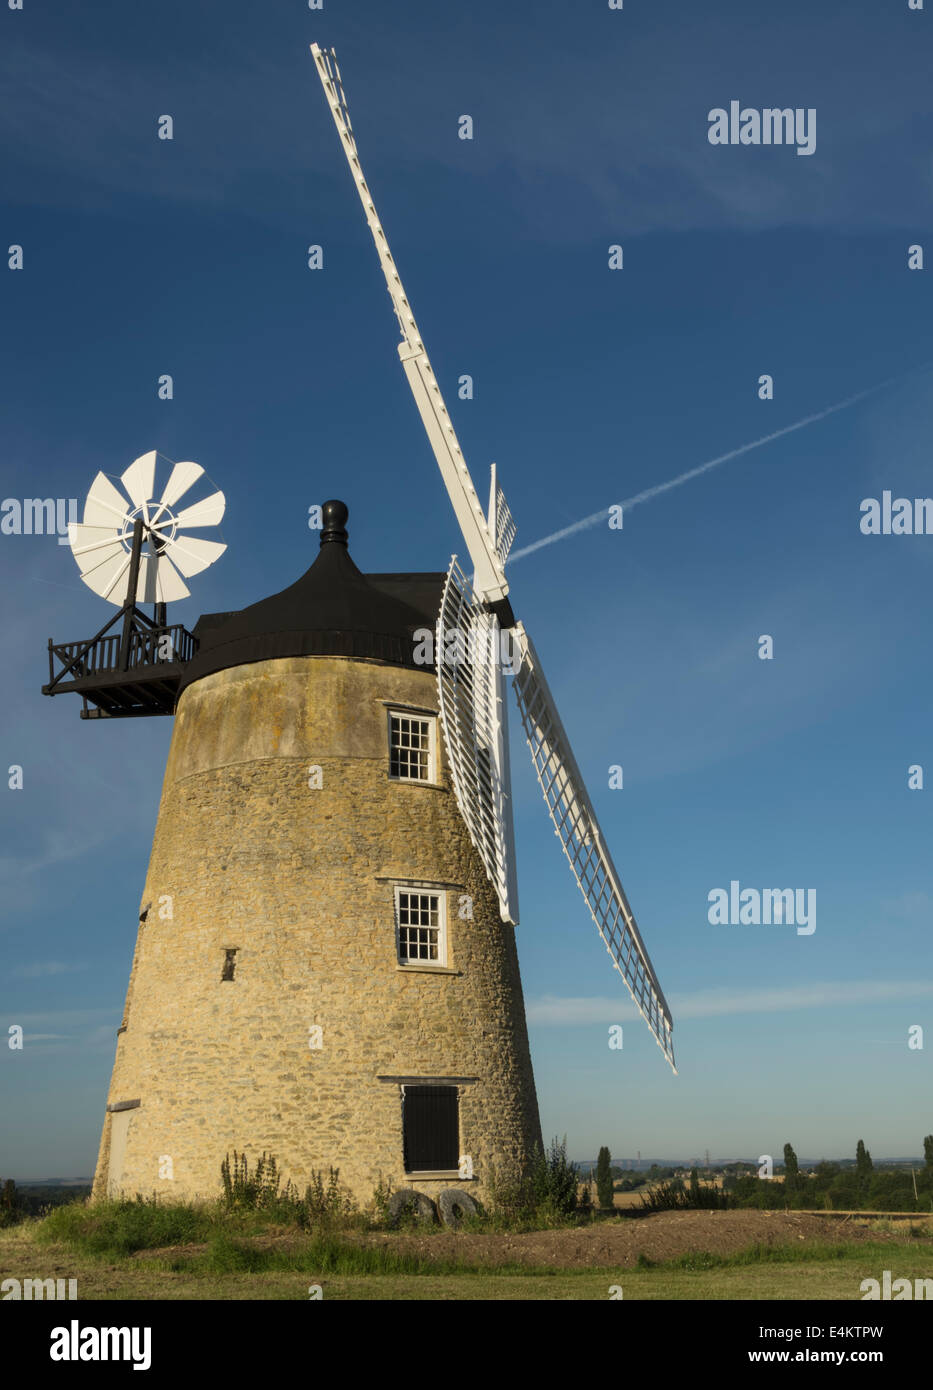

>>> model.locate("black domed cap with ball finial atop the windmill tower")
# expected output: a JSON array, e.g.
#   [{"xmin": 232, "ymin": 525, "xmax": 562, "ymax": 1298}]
[{"xmin": 179, "ymin": 500, "xmax": 445, "ymax": 694}]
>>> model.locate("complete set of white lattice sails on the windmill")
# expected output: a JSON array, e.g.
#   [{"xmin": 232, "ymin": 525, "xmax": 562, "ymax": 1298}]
[{"xmin": 311, "ymin": 43, "xmax": 674, "ymax": 1068}]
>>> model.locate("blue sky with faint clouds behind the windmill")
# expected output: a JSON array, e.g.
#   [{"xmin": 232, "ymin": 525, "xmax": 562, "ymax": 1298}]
[{"xmin": 0, "ymin": 0, "xmax": 933, "ymax": 1177}]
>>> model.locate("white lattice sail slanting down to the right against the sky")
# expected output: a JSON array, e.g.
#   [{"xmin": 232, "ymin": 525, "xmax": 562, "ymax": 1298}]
[{"xmin": 513, "ymin": 623, "xmax": 677, "ymax": 1072}]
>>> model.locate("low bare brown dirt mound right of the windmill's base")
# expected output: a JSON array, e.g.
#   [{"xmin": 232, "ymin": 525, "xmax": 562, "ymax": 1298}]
[{"xmin": 355, "ymin": 1211, "xmax": 933, "ymax": 1269}]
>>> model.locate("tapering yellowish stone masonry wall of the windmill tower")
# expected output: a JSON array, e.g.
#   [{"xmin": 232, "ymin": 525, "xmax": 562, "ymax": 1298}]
[{"xmin": 95, "ymin": 657, "xmax": 541, "ymax": 1202}]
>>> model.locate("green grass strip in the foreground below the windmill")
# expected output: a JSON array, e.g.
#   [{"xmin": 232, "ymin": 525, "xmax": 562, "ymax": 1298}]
[{"xmin": 9, "ymin": 1202, "xmax": 933, "ymax": 1301}]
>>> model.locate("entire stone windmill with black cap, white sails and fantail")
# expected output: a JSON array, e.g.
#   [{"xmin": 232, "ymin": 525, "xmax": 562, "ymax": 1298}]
[{"xmin": 43, "ymin": 46, "xmax": 673, "ymax": 1217}]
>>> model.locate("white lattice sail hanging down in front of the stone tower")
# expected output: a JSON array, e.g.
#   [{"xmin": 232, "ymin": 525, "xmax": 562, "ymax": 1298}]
[{"xmin": 435, "ymin": 556, "xmax": 519, "ymax": 926}]
